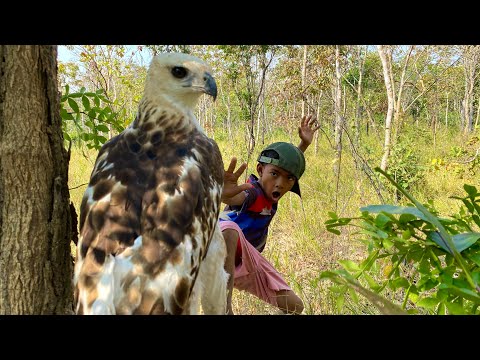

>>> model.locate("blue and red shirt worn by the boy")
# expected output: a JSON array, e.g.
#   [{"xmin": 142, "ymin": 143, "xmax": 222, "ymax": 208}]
[{"xmin": 220, "ymin": 174, "xmax": 278, "ymax": 252}]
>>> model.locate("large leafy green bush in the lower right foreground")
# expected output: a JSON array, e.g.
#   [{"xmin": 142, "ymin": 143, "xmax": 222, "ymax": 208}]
[{"xmin": 320, "ymin": 168, "xmax": 480, "ymax": 314}]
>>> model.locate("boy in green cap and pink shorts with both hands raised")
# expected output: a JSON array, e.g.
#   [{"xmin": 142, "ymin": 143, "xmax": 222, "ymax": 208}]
[{"xmin": 220, "ymin": 115, "xmax": 320, "ymax": 315}]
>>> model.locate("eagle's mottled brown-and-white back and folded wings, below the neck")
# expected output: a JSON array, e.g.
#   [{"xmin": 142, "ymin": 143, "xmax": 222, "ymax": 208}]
[{"xmin": 76, "ymin": 114, "xmax": 223, "ymax": 314}]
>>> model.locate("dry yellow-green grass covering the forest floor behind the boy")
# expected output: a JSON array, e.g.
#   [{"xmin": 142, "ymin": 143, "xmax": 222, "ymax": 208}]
[{"xmin": 69, "ymin": 125, "xmax": 480, "ymax": 314}]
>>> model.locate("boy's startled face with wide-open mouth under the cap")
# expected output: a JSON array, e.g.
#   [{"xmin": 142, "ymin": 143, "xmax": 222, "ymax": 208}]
[{"xmin": 257, "ymin": 163, "xmax": 296, "ymax": 203}]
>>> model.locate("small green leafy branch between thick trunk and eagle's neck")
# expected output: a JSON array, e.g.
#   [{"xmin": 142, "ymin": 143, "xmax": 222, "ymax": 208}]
[{"xmin": 60, "ymin": 85, "xmax": 124, "ymax": 150}]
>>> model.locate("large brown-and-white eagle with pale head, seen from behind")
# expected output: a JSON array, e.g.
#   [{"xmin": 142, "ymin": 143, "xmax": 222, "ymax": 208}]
[{"xmin": 74, "ymin": 53, "xmax": 228, "ymax": 315}]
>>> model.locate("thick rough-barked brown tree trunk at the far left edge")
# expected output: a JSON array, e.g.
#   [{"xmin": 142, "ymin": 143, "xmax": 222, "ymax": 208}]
[{"xmin": 0, "ymin": 45, "xmax": 73, "ymax": 314}]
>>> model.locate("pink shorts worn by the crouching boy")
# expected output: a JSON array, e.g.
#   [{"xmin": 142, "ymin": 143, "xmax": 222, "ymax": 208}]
[{"xmin": 220, "ymin": 221, "xmax": 292, "ymax": 306}]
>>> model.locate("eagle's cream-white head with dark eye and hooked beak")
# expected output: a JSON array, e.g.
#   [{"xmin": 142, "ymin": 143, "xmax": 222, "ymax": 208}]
[{"xmin": 145, "ymin": 53, "xmax": 217, "ymax": 110}]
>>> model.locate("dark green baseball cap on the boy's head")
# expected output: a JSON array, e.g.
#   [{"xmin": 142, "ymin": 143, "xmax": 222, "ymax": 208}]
[{"xmin": 257, "ymin": 141, "xmax": 305, "ymax": 197}]
